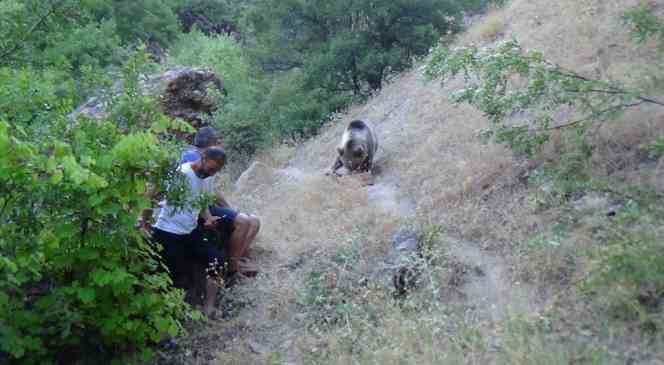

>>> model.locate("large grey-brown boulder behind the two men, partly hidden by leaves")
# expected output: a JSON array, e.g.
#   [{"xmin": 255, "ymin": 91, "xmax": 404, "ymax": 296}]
[{"xmin": 71, "ymin": 67, "xmax": 224, "ymax": 128}]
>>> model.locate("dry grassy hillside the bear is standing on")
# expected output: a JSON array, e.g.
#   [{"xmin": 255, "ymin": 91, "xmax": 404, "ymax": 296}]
[{"xmin": 160, "ymin": 0, "xmax": 664, "ymax": 364}]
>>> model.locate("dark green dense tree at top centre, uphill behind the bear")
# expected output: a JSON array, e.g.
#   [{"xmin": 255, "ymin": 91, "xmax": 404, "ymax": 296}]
[{"xmin": 248, "ymin": 0, "xmax": 461, "ymax": 95}]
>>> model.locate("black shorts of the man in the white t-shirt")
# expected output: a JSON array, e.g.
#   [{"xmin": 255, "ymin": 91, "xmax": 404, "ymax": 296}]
[{"xmin": 152, "ymin": 228, "xmax": 224, "ymax": 279}]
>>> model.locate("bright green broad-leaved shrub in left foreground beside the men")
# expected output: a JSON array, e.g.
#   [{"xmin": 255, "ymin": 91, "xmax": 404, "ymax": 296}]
[{"xmin": 0, "ymin": 49, "xmax": 196, "ymax": 363}]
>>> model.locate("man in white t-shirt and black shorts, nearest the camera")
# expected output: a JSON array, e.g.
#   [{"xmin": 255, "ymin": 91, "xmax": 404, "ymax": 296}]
[{"xmin": 152, "ymin": 147, "xmax": 226, "ymax": 316}]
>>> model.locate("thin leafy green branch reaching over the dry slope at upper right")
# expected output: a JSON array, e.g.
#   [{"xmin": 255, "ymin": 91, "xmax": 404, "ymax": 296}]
[{"xmin": 425, "ymin": 40, "xmax": 664, "ymax": 155}]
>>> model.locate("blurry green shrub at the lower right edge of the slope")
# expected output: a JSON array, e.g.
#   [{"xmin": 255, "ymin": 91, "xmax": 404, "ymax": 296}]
[{"xmin": 582, "ymin": 195, "xmax": 664, "ymax": 331}]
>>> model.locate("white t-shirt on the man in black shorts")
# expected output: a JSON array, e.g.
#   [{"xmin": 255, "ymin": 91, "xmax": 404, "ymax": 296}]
[{"xmin": 154, "ymin": 162, "xmax": 214, "ymax": 234}]
